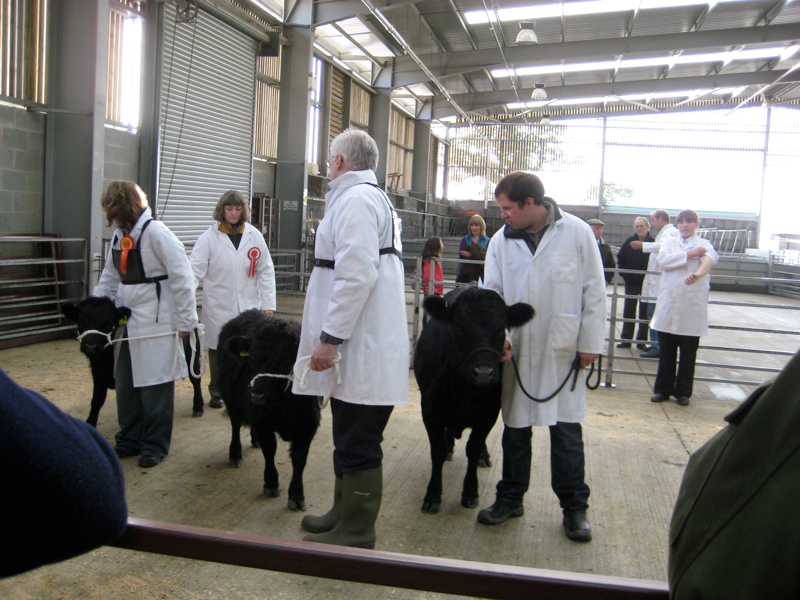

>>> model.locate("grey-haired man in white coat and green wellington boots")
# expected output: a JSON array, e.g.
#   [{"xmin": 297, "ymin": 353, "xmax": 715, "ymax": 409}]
[{"xmin": 293, "ymin": 130, "xmax": 409, "ymax": 548}]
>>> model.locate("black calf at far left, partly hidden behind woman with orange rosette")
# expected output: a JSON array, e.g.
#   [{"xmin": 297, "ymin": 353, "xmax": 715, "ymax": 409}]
[{"xmin": 61, "ymin": 296, "xmax": 203, "ymax": 427}]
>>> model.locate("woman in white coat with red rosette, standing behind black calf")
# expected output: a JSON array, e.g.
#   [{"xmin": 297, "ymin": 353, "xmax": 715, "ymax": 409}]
[{"xmin": 189, "ymin": 190, "xmax": 276, "ymax": 408}]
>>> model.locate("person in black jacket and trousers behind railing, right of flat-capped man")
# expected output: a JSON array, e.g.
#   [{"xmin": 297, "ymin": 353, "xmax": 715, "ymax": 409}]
[{"xmin": 617, "ymin": 217, "xmax": 655, "ymax": 350}]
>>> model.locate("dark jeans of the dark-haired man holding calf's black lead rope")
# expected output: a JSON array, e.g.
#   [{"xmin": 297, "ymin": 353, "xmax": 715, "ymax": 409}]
[{"xmin": 497, "ymin": 422, "xmax": 590, "ymax": 514}]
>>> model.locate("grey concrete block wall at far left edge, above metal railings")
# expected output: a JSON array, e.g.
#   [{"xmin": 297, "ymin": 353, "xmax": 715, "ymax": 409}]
[{"xmin": 0, "ymin": 104, "xmax": 46, "ymax": 234}]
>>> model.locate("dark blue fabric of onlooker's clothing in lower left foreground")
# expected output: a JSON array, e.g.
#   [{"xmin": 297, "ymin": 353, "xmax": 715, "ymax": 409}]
[{"xmin": 0, "ymin": 370, "xmax": 128, "ymax": 577}]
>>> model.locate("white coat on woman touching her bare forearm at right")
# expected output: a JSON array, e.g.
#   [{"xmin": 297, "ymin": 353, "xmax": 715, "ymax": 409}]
[{"xmin": 650, "ymin": 235, "xmax": 719, "ymax": 337}]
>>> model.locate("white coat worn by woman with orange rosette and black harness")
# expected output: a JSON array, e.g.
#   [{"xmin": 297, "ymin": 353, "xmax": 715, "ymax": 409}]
[{"xmin": 92, "ymin": 208, "xmax": 197, "ymax": 387}]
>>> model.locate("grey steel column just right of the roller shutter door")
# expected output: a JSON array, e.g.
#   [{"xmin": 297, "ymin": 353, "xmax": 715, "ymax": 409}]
[{"xmin": 275, "ymin": 24, "xmax": 312, "ymax": 250}]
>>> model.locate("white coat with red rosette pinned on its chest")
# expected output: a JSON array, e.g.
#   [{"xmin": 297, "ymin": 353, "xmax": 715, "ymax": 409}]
[{"xmin": 189, "ymin": 223, "xmax": 276, "ymax": 350}]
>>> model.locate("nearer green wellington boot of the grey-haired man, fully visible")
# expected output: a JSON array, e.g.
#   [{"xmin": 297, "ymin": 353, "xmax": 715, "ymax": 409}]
[{"xmin": 303, "ymin": 467, "xmax": 383, "ymax": 549}]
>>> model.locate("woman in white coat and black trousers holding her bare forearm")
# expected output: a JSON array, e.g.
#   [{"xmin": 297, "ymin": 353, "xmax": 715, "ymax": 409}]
[{"xmin": 650, "ymin": 210, "xmax": 719, "ymax": 406}]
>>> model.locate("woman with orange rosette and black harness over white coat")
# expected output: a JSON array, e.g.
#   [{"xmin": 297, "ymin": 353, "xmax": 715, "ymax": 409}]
[{"xmin": 93, "ymin": 181, "xmax": 197, "ymax": 467}]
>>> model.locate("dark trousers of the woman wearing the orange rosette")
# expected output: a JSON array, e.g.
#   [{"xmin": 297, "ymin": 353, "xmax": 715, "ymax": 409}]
[{"xmin": 115, "ymin": 342, "xmax": 175, "ymax": 458}]
